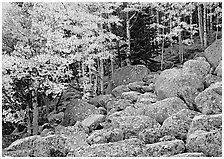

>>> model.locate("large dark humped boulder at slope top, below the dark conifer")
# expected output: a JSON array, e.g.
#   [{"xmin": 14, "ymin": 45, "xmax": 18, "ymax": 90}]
[{"xmin": 107, "ymin": 65, "xmax": 150, "ymax": 90}]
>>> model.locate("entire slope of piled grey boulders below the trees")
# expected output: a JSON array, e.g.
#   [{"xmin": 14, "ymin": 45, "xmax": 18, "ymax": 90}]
[{"xmin": 3, "ymin": 40, "xmax": 222, "ymax": 157}]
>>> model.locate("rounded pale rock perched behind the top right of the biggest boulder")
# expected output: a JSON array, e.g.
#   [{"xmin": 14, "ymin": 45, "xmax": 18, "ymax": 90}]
[{"xmin": 182, "ymin": 60, "xmax": 210, "ymax": 78}]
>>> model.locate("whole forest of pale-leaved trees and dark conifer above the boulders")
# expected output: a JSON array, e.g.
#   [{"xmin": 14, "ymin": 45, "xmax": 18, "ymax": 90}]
[{"xmin": 2, "ymin": 2, "xmax": 222, "ymax": 154}]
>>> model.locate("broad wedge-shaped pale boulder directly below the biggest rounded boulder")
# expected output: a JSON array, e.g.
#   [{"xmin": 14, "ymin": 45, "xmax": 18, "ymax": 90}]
[{"xmin": 144, "ymin": 97, "xmax": 187, "ymax": 124}]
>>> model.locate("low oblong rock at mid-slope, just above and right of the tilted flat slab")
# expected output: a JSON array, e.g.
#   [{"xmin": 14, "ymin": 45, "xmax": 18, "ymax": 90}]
[{"xmin": 106, "ymin": 99, "xmax": 132, "ymax": 111}]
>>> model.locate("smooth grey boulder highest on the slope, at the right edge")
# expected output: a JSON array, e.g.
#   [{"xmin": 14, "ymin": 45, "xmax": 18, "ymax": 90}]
[{"xmin": 204, "ymin": 39, "xmax": 222, "ymax": 68}]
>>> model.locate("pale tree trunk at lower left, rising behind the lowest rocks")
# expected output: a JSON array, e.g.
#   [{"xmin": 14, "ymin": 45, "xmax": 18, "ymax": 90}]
[{"xmin": 32, "ymin": 91, "xmax": 39, "ymax": 135}]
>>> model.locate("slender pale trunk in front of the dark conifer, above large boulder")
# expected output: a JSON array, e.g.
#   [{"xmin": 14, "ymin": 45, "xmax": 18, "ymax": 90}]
[{"xmin": 126, "ymin": 12, "xmax": 131, "ymax": 66}]
